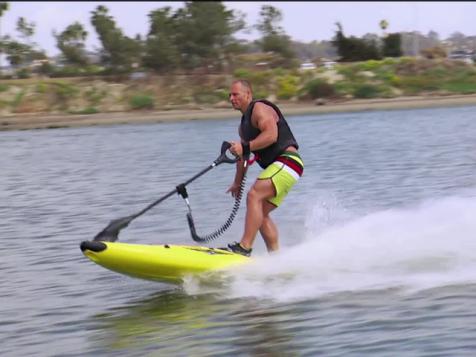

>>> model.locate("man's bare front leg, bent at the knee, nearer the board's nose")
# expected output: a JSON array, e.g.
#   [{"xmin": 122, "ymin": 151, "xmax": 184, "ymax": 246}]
[{"xmin": 240, "ymin": 179, "xmax": 276, "ymax": 249}]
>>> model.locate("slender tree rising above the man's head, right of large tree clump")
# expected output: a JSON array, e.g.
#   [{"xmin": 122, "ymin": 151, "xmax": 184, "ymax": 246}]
[{"xmin": 256, "ymin": 5, "xmax": 296, "ymax": 67}]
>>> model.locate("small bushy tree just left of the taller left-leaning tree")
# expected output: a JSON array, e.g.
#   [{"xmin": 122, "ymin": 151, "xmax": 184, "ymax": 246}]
[{"xmin": 53, "ymin": 22, "xmax": 88, "ymax": 65}]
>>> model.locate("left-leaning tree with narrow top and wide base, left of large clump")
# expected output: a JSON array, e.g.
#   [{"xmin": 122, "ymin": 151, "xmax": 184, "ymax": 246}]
[{"xmin": 91, "ymin": 5, "xmax": 142, "ymax": 72}]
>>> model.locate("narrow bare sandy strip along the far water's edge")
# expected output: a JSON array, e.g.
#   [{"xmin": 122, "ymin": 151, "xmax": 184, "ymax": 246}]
[{"xmin": 0, "ymin": 94, "xmax": 476, "ymax": 131}]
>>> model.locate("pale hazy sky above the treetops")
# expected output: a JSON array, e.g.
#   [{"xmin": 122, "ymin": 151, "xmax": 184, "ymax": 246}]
[{"xmin": 0, "ymin": 1, "xmax": 476, "ymax": 55}]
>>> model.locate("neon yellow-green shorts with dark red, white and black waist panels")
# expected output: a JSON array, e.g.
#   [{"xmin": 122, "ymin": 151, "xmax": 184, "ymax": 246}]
[{"xmin": 258, "ymin": 151, "xmax": 304, "ymax": 207}]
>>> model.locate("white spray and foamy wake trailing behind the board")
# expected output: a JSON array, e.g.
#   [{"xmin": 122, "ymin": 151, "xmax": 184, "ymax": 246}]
[{"xmin": 185, "ymin": 192, "xmax": 476, "ymax": 301}]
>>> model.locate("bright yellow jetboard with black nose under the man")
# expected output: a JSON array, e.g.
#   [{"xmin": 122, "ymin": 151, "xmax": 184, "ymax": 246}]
[{"xmin": 80, "ymin": 241, "xmax": 250, "ymax": 283}]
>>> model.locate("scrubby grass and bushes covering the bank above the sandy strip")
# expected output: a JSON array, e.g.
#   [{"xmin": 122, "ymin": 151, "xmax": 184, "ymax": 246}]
[{"xmin": 0, "ymin": 57, "xmax": 476, "ymax": 115}]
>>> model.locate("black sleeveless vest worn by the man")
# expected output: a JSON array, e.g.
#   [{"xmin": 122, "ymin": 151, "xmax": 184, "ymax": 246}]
[{"xmin": 240, "ymin": 99, "xmax": 299, "ymax": 168}]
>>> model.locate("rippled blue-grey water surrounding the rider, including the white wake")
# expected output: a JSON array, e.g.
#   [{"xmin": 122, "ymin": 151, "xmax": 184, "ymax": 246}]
[{"xmin": 0, "ymin": 107, "xmax": 476, "ymax": 356}]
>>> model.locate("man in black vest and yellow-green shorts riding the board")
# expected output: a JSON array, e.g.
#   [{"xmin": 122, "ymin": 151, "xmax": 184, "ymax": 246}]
[{"xmin": 227, "ymin": 80, "xmax": 304, "ymax": 256}]
